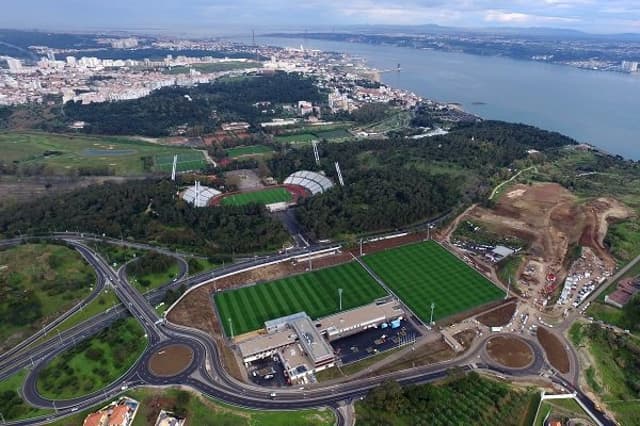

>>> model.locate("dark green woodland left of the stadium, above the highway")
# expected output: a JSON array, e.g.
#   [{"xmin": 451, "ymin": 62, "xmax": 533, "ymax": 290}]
[{"xmin": 0, "ymin": 180, "xmax": 288, "ymax": 255}]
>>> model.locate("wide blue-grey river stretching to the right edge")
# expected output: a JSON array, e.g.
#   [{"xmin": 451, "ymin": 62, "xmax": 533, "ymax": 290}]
[{"xmin": 242, "ymin": 38, "xmax": 640, "ymax": 160}]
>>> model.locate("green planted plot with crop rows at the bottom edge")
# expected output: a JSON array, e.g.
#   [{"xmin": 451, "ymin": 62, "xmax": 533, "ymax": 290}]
[{"xmin": 355, "ymin": 373, "xmax": 539, "ymax": 426}]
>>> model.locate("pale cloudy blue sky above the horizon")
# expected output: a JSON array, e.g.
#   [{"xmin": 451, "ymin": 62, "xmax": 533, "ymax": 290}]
[{"xmin": 5, "ymin": 0, "xmax": 640, "ymax": 34}]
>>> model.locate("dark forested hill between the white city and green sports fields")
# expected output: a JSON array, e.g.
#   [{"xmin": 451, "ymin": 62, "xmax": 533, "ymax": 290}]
[{"xmin": 64, "ymin": 72, "xmax": 325, "ymax": 136}]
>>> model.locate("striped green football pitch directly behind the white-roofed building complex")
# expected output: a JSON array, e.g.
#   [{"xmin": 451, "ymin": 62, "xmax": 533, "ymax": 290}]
[{"xmin": 214, "ymin": 262, "xmax": 386, "ymax": 335}]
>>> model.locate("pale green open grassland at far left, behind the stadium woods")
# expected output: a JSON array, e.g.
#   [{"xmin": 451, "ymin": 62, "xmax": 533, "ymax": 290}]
[{"xmin": 0, "ymin": 132, "xmax": 204, "ymax": 176}]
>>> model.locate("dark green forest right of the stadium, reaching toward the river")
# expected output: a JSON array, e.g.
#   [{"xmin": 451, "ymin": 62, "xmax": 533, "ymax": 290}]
[{"xmin": 269, "ymin": 121, "xmax": 575, "ymax": 238}]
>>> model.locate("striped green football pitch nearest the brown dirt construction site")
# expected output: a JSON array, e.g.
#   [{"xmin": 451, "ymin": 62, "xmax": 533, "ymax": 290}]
[{"xmin": 364, "ymin": 241, "xmax": 504, "ymax": 322}]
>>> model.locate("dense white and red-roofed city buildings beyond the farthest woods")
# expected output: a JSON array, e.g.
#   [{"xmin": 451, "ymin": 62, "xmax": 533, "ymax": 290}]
[{"xmin": 0, "ymin": 38, "xmax": 421, "ymax": 116}]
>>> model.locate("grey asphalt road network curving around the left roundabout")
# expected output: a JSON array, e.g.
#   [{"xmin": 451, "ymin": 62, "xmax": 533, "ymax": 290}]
[{"xmin": 0, "ymin": 235, "xmax": 612, "ymax": 425}]
